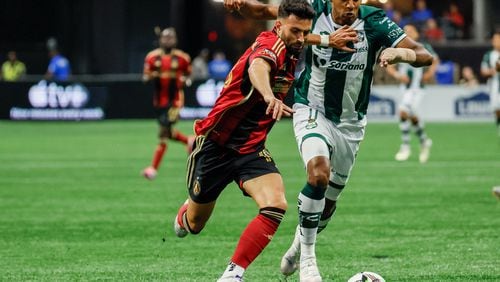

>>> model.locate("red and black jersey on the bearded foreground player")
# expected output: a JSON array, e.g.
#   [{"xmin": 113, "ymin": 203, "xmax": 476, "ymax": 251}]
[{"xmin": 194, "ymin": 30, "xmax": 297, "ymax": 154}]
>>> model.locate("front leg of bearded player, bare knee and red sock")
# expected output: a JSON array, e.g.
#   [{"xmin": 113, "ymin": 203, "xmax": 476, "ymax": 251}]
[{"xmin": 219, "ymin": 173, "xmax": 287, "ymax": 281}]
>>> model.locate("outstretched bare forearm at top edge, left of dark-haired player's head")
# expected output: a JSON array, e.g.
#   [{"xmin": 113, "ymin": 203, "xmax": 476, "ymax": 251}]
[{"xmin": 224, "ymin": 0, "xmax": 278, "ymax": 20}]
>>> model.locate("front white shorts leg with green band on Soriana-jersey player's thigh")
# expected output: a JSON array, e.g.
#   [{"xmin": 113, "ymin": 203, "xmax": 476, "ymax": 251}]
[{"xmin": 293, "ymin": 106, "xmax": 332, "ymax": 166}]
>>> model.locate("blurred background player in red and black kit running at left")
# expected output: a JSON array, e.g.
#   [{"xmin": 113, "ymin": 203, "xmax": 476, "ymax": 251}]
[{"xmin": 142, "ymin": 28, "xmax": 193, "ymax": 180}]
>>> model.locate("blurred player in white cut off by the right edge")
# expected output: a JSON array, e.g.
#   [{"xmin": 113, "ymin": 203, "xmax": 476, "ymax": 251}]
[{"xmin": 481, "ymin": 31, "xmax": 500, "ymax": 136}]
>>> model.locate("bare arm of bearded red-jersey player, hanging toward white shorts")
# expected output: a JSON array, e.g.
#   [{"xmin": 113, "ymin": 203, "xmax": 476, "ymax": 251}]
[{"xmin": 248, "ymin": 58, "xmax": 293, "ymax": 120}]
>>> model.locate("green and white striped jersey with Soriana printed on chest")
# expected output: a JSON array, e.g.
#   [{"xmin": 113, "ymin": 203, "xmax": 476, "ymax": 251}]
[{"xmin": 294, "ymin": 0, "xmax": 406, "ymax": 123}]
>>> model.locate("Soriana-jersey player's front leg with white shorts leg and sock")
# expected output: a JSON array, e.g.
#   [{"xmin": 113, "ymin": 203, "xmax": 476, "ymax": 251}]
[{"xmin": 280, "ymin": 106, "xmax": 332, "ymax": 281}]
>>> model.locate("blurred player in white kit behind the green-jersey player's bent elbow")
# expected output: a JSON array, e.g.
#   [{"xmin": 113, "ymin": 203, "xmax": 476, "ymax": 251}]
[{"xmin": 387, "ymin": 24, "xmax": 439, "ymax": 163}]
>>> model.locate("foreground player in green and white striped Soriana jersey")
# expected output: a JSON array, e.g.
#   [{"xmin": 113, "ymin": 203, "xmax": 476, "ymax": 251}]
[{"xmin": 224, "ymin": 0, "xmax": 433, "ymax": 281}]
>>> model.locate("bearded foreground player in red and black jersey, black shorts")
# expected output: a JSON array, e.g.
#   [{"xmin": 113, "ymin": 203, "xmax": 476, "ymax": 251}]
[{"xmin": 174, "ymin": 0, "xmax": 315, "ymax": 281}]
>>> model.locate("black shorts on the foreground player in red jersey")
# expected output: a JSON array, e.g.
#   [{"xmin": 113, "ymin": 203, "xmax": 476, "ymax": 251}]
[{"xmin": 187, "ymin": 136, "xmax": 279, "ymax": 204}]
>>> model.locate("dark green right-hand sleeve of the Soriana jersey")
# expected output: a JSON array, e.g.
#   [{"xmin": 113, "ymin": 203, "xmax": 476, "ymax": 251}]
[{"xmin": 367, "ymin": 10, "xmax": 406, "ymax": 47}]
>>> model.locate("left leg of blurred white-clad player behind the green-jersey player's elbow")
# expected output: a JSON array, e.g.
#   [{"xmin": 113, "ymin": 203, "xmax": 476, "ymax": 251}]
[{"xmin": 394, "ymin": 91, "xmax": 413, "ymax": 161}]
